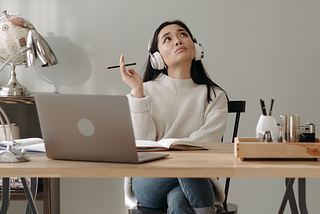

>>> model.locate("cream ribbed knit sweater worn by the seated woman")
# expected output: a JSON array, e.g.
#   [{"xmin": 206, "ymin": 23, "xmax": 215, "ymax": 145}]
[{"xmin": 125, "ymin": 75, "xmax": 228, "ymax": 204}]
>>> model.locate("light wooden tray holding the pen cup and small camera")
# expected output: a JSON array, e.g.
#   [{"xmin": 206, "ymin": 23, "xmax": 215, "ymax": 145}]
[{"xmin": 234, "ymin": 137, "xmax": 320, "ymax": 161}]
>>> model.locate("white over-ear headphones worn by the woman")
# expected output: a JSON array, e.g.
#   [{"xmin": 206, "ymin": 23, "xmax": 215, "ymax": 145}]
[{"xmin": 148, "ymin": 37, "xmax": 204, "ymax": 70}]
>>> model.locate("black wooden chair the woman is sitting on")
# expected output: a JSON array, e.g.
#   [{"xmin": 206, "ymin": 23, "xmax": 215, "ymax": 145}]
[{"xmin": 129, "ymin": 100, "xmax": 246, "ymax": 214}]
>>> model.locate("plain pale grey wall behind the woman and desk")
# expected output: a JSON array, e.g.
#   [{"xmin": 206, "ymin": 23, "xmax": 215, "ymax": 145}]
[{"xmin": 0, "ymin": 0, "xmax": 320, "ymax": 214}]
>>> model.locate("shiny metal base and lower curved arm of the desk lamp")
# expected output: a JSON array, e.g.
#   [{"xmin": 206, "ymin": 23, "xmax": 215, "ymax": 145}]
[{"xmin": 0, "ymin": 106, "xmax": 30, "ymax": 163}]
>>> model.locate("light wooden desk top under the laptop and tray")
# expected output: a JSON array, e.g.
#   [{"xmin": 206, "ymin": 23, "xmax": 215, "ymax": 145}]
[{"xmin": 0, "ymin": 143, "xmax": 320, "ymax": 178}]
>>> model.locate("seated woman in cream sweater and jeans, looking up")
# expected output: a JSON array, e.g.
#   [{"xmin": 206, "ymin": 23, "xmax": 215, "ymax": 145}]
[{"xmin": 120, "ymin": 20, "xmax": 228, "ymax": 214}]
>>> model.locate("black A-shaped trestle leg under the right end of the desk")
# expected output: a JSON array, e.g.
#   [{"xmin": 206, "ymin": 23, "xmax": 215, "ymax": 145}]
[{"xmin": 278, "ymin": 178, "xmax": 298, "ymax": 214}]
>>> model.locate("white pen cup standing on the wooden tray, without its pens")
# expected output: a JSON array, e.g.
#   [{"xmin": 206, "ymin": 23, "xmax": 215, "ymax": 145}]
[{"xmin": 256, "ymin": 115, "xmax": 278, "ymax": 142}]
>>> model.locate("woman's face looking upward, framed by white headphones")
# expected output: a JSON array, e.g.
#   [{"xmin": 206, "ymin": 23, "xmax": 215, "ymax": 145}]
[{"xmin": 158, "ymin": 24, "xmax": 195, "ymax": 67}]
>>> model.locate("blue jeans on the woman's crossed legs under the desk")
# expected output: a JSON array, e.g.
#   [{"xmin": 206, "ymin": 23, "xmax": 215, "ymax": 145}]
[{"xmin": 132, "ymin": 178, "xmax": 215, "ymax": 214}]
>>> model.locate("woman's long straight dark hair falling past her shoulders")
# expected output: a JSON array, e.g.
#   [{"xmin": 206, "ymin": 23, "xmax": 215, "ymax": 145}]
[{"xmin": 143, "ymin": 20, "xmax": 225, "ymax": 102}]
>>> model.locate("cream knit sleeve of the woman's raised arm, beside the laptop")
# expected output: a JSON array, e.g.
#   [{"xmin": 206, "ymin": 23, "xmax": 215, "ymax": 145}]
[{"xmin": 127, "ymin": 94, "xmax": 156, "ymax": 140}]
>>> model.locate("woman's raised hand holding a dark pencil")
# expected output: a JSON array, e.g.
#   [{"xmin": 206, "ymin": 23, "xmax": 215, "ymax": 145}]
[{"xmin": 119, "ymin": 55, "xmax": 144, "ymax": 98}]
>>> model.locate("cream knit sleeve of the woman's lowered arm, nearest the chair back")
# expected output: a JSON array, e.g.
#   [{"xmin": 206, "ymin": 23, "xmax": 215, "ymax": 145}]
[{"xmin": 185, "ymin": 89, "xmax": 228, "ymax": 143}]
